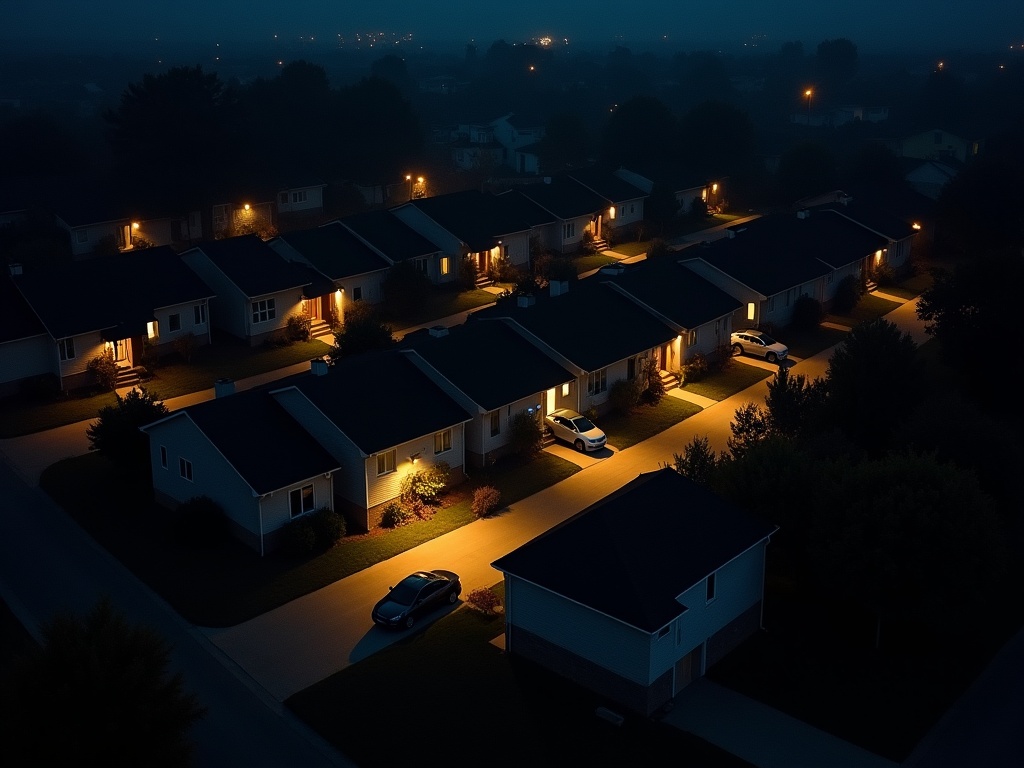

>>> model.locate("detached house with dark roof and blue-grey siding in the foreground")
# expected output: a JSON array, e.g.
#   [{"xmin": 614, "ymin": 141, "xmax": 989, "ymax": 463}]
[{"xmin": 492, "ymin": 468, "xmax": 777, "ymax": 716}]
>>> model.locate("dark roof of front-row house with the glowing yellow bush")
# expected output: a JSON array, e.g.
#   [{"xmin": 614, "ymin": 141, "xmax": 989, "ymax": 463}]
[{"xmin": 280, "ymin": 349, "xmax": 470, "ymax": 456}]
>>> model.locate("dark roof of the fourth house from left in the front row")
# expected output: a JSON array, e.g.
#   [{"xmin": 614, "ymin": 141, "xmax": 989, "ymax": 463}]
[{"xmin": 469, "ymin": 278, "xmax": 676, "ymax": 372}]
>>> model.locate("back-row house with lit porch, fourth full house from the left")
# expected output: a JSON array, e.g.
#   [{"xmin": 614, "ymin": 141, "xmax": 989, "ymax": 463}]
[{"xmin": 391, "ymin": 189, "xmax": 532, "ymax": 283}]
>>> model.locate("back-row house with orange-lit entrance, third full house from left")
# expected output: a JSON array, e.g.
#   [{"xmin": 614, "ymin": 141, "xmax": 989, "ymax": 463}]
[{"xmin": 268, "ymin": 221, "xmax": 391, "ymax": 338}]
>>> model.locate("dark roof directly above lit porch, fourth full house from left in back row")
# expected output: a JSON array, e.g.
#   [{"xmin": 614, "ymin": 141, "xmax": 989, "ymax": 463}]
[{"xmin": 408, "ymin": 189, "xmax": 530, "ymax": 251}]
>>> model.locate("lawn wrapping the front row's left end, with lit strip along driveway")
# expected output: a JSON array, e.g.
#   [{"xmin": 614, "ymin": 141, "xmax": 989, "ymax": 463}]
[{"xmin": 40, "ymin": 453, "xmax": 580, "ymax": 627}]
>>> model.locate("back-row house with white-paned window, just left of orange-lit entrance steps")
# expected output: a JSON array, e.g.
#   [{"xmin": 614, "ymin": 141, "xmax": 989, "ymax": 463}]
[{"xmin": 181, "ymin": 234, "xmax": 313, "ymax": 346}]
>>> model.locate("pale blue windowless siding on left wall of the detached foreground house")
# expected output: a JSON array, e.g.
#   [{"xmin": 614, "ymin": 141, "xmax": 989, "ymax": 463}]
[{"xmin": 505, "ymin": 575, "xmax": 650, "ymax": 685}]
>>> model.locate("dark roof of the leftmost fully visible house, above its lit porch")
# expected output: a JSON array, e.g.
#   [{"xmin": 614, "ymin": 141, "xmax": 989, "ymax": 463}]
[{"xmin": 15, "ymin": 246, "xmax": 214, "ymax": 339}]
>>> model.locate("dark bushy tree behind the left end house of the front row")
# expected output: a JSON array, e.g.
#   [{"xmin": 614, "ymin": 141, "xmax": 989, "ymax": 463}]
[{"xmin": 85, "ymin": 387, "xmax": 168, "ymax": 469}]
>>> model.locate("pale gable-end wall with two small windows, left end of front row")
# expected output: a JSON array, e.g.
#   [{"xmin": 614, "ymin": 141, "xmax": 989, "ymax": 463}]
[{"xmin": 150, "ymin": 416, "xmax": 270, "ymax": 551}]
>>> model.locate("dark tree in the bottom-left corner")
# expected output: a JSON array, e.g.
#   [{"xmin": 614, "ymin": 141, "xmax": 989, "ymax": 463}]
[{"xmin": 0, "ymin": 599, "xmax": 204, "ymax": 768}]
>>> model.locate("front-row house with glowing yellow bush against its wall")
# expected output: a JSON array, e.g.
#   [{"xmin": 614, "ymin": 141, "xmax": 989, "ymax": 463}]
[{"xmin": 270, "ymin": 349, "xmax": 471, "ymax": 530}]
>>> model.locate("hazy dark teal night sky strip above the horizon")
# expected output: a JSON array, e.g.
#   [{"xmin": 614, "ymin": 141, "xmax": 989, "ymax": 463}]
[{"xmin": 8, "ymin": 0, "xmax": 1024, "ymax": 52}]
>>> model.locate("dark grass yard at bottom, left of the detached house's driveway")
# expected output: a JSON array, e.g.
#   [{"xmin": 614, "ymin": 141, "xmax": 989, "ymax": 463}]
[{"xmin": 285, "ymin": 585, "xmax": 748, "ymax": 768}]
